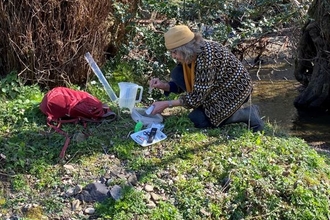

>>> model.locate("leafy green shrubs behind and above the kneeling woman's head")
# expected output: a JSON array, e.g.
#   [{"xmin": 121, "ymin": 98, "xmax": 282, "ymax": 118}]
[{"xmin": 107, "ymin": 0, "xmax": 311, "ymax": 89}]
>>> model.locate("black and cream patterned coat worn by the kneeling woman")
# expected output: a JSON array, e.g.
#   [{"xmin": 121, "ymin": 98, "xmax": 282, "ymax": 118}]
[{"xmin": 180, "ymin": 41, "xmax": 252, "ymax": 126}]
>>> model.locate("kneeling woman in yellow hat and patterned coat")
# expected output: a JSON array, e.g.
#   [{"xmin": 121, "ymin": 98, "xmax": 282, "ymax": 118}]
[{"xmin": 149, "ymin": 25, "xmax": 264, "ymax": 132}]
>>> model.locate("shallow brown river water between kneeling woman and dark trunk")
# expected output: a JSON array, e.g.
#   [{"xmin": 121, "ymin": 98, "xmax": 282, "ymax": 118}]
[{"xmin": 248, "ymin": 61, "xmax": 330, "ymax": 147}]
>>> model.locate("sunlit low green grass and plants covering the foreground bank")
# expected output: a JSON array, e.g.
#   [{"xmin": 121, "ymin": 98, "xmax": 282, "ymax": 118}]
[{"xmin": 0, "ymin": 73, "xmax": 330, "ymax": 219}]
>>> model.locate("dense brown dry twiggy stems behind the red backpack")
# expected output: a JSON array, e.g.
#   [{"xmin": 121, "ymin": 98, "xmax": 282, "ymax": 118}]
[{"xmin": 0, "ymin": 0, "xmax": 137, "ymax": 87}]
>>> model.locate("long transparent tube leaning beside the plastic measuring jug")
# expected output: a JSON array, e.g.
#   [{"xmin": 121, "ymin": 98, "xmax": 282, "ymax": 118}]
[{"xmin": 85, "ymin": 52, "xmax": 118, "ymax": 102}]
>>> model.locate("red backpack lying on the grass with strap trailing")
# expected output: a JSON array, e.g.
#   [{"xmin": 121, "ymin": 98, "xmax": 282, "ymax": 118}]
[{"xmin": 40, "ymin": 87, "xmax": 116, "ymax": 158}]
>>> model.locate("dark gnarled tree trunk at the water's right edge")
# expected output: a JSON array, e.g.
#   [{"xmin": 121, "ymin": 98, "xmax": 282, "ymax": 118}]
[{"xmin": 294, "ymin": 0, "xmax": 330, "ymax": 111}]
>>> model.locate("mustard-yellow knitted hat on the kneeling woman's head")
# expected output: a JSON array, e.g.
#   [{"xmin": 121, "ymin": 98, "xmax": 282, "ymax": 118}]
[{"xmin": 164, "ymin": 25, "xmax": 195, "ymax": 50}]
